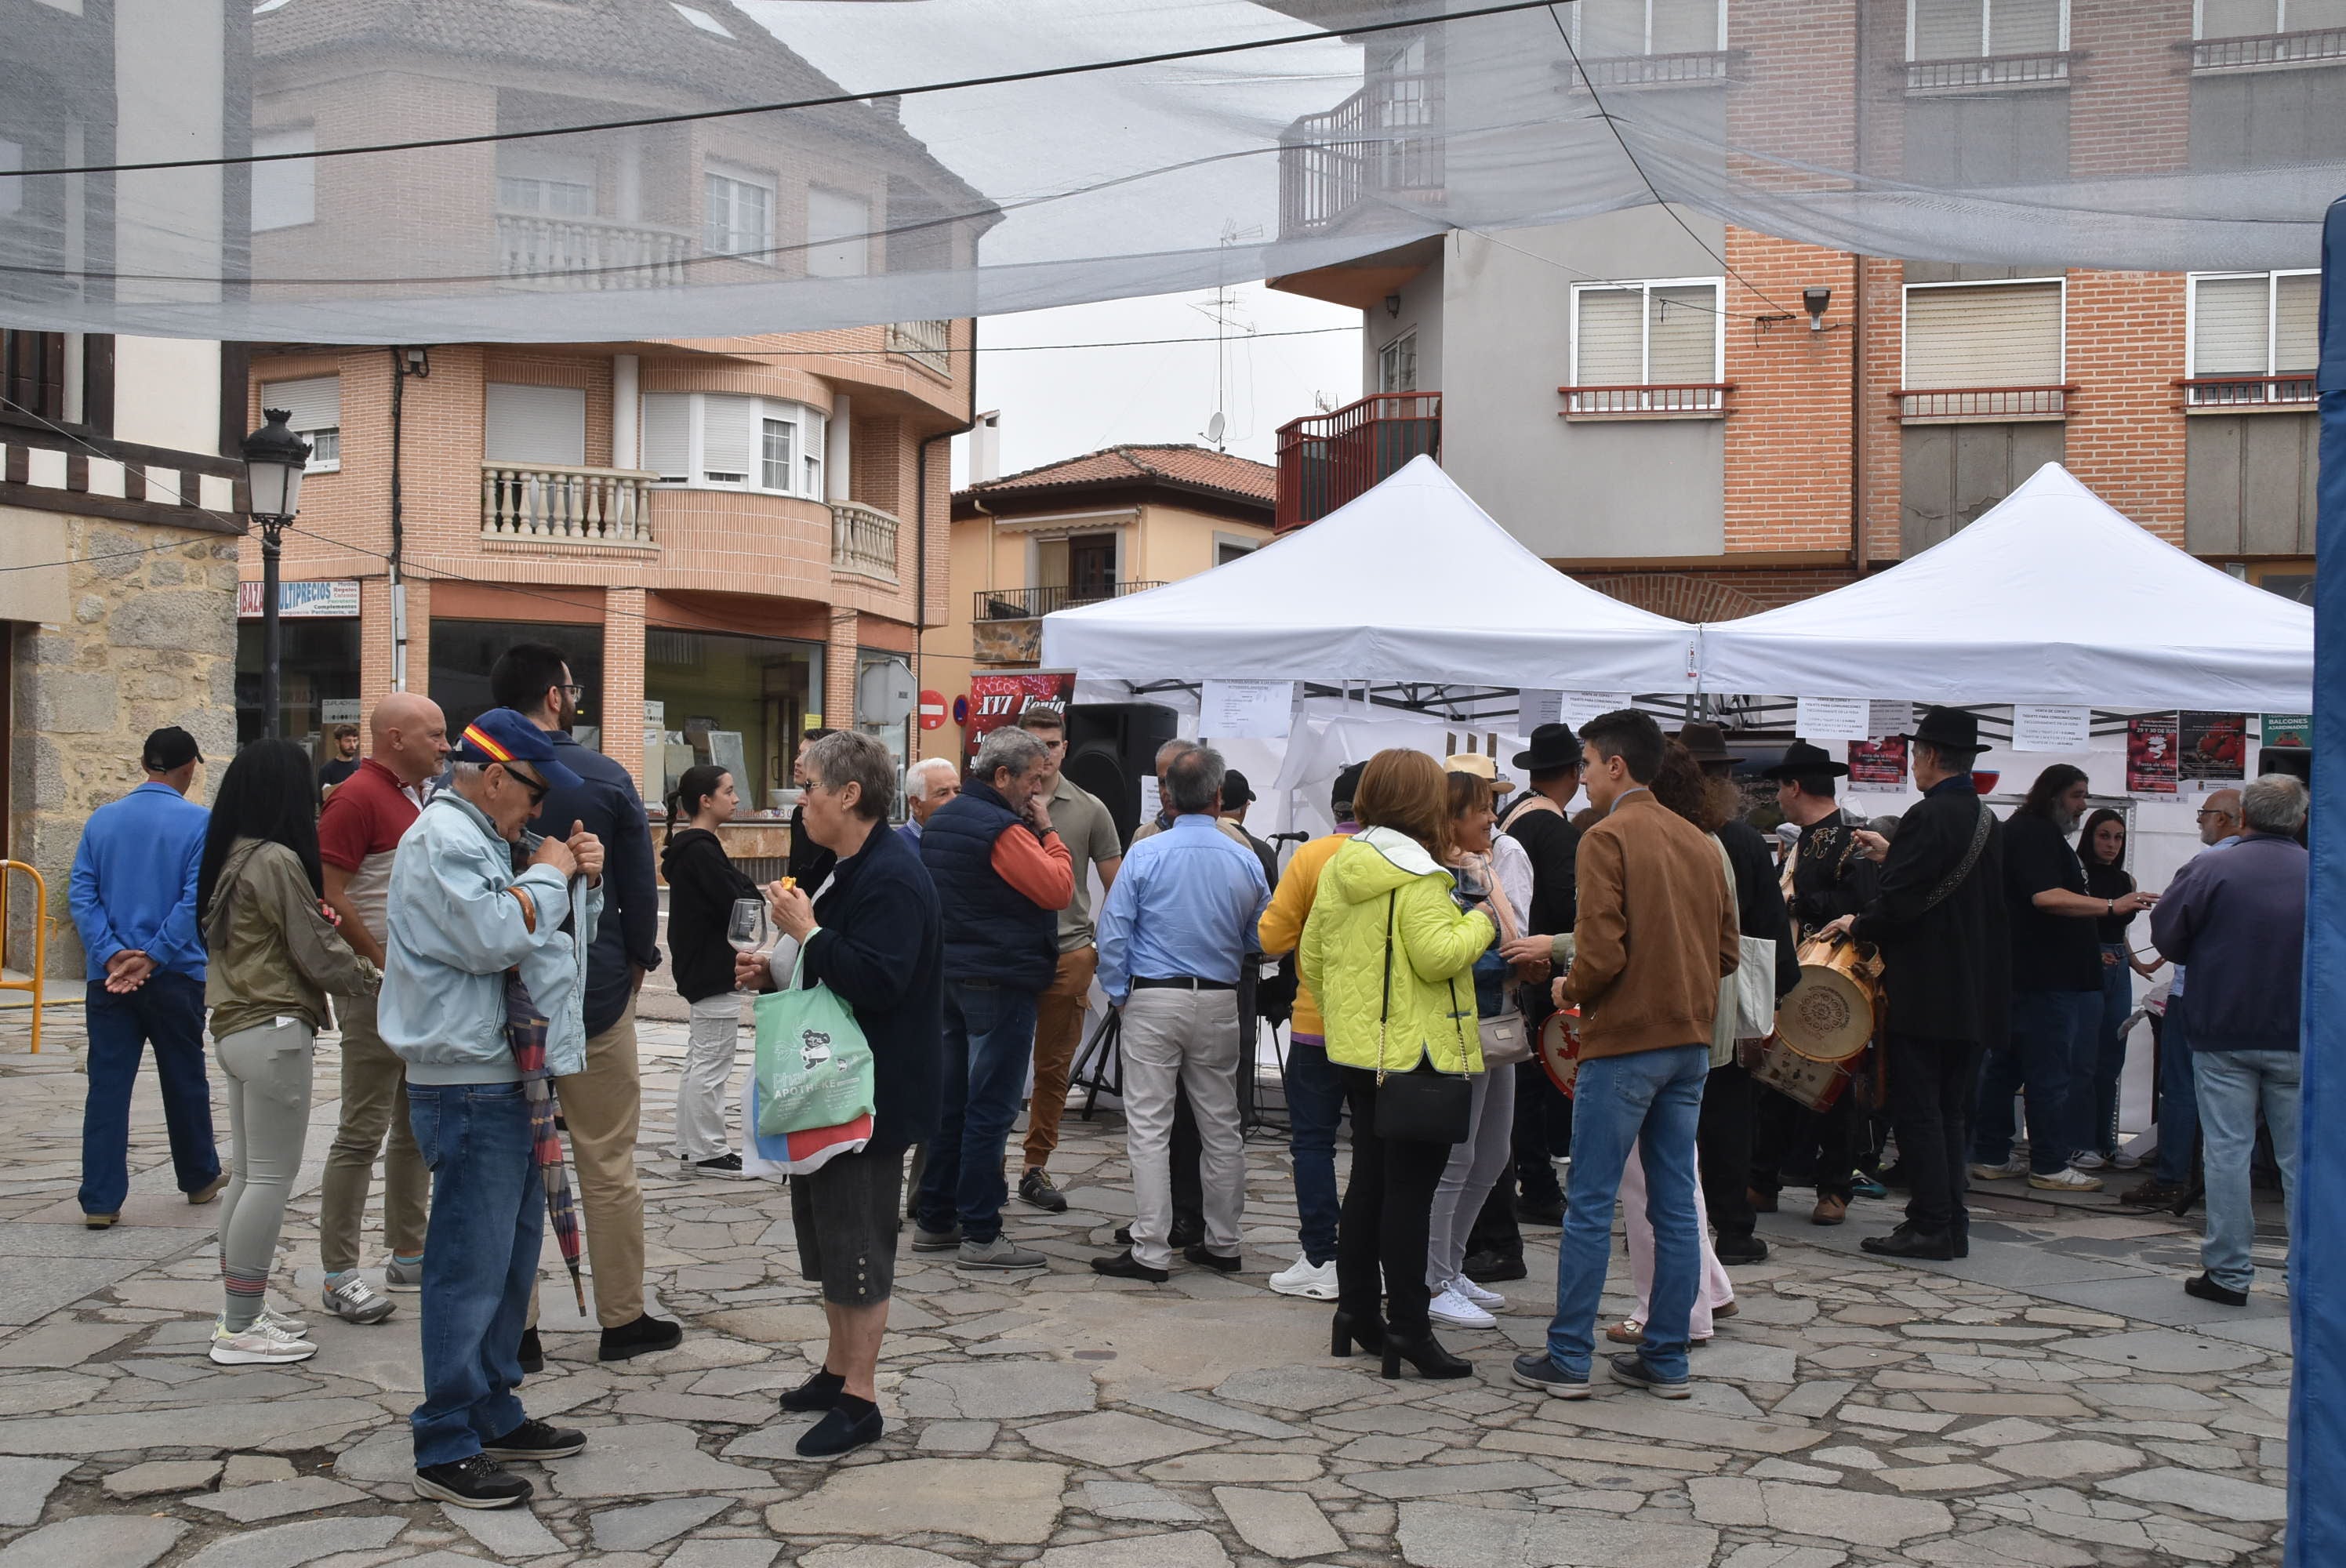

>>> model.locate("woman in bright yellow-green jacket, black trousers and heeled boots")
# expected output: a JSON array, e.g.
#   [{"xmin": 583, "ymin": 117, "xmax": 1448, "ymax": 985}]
[{"xmin": 1295, "ymin": 751, "xmax": 1497, "ymax": 1377}]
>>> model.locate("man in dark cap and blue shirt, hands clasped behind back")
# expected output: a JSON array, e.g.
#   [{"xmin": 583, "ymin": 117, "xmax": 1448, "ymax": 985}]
[{"xmin": 71, "ymin": 725, "xmax": 227, "ymax": 1230}]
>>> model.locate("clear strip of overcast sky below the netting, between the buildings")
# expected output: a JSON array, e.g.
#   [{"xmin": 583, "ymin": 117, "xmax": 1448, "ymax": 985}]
[{"xmin": 953, "ymin": 284, "xmax": 1360, "ymax": 486}]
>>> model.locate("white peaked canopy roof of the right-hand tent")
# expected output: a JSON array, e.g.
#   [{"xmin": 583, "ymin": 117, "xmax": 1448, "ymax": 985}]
[{"xmin": 1701, "ymin": 463, "xmax": 2313, "ymax": 713}]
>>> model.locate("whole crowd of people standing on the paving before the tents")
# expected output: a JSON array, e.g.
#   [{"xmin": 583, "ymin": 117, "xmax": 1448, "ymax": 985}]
[{"xmin": 59, "ymin": 690, "xmax": 2306, "ymax": 1507}]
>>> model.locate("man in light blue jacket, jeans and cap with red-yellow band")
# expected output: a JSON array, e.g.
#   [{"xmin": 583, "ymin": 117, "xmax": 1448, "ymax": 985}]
[{"xmin": 376, "ymin": 709, "xmax": 603, "ymax": 1507}]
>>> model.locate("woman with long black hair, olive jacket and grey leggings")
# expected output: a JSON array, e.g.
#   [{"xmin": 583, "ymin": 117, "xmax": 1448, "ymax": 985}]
[{"xmin": 194, "ymin": 739, "xmax": 390, "ymax": 1367}]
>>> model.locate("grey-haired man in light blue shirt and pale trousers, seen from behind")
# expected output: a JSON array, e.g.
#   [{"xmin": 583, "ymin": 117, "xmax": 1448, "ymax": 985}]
[{"xmin": 1091, "ymin": 746, "xmax": 1272, "ymax": 1282}]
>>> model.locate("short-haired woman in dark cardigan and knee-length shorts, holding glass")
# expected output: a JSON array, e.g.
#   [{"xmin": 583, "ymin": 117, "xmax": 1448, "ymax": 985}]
[{"xmin": 739, "ymin": 732, "xmax": 946, "ymax": 1457}]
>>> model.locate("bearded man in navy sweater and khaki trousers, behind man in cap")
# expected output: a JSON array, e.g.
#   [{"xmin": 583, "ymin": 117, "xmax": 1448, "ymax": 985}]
[{"xmin": 488, "ymin": 643, "xmax": 685, "ymax": 1371}]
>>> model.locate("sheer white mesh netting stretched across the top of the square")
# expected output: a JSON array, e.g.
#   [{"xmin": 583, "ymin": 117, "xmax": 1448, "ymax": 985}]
[{"xmin": 0, "ymin": 0, "xmax": 2346, "ymax": 343}]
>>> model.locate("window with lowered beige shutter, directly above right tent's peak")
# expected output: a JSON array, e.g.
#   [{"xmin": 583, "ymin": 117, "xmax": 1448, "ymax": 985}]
[{"xmin": 1901, "ymin": 277, "xmax": 2067, "ymax": 420}]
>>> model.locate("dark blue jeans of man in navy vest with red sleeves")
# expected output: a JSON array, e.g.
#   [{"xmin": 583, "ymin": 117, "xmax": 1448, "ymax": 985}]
[{"xmin": 920, "ymin": 981, "xmax": 1034, "ymax": 1242}]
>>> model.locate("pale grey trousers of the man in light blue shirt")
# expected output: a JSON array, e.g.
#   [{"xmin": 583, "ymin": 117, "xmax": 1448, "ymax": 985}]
[{"xmin": 1124, "ymin": 988, "xmax": 1246, "ymax": 1268}]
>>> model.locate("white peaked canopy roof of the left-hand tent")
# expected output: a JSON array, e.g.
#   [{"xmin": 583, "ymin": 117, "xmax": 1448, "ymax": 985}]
[{"xmin": 1041, "ymin": 458, "xmax": 1694, "ymax": 699}]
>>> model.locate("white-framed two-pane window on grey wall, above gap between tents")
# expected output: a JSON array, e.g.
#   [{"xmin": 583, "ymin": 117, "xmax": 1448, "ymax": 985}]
[{"xmin": 1565, "ymin": 277, "xmax": 1727, "ymax": 413}]
